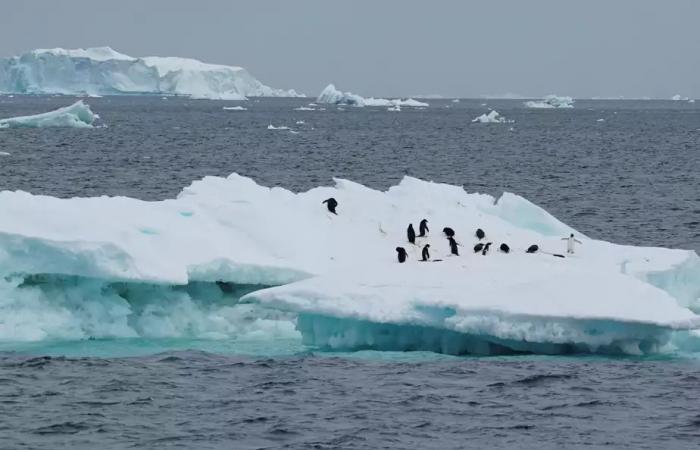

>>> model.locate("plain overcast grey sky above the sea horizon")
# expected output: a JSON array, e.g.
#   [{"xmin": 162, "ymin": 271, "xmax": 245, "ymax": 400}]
[{"xmin": 0, "ymin": 0, "xmax": 700, "ymax": 98}]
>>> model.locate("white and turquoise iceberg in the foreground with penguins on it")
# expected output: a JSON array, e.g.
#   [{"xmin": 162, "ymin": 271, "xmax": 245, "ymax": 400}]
[{"xmin": 0, "ymin": 174, "xmax": 700, "ymax": 354}]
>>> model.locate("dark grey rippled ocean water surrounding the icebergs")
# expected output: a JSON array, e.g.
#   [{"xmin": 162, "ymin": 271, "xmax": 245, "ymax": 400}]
[{"xmin": 0, "ymin": 96, "xmax": 700, "ymax": 449}]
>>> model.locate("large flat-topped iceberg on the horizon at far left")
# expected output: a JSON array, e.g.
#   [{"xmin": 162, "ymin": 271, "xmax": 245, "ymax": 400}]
[{"xmin": 0, "ymin": 47, "xmax": 298, "ymax": 100}]
